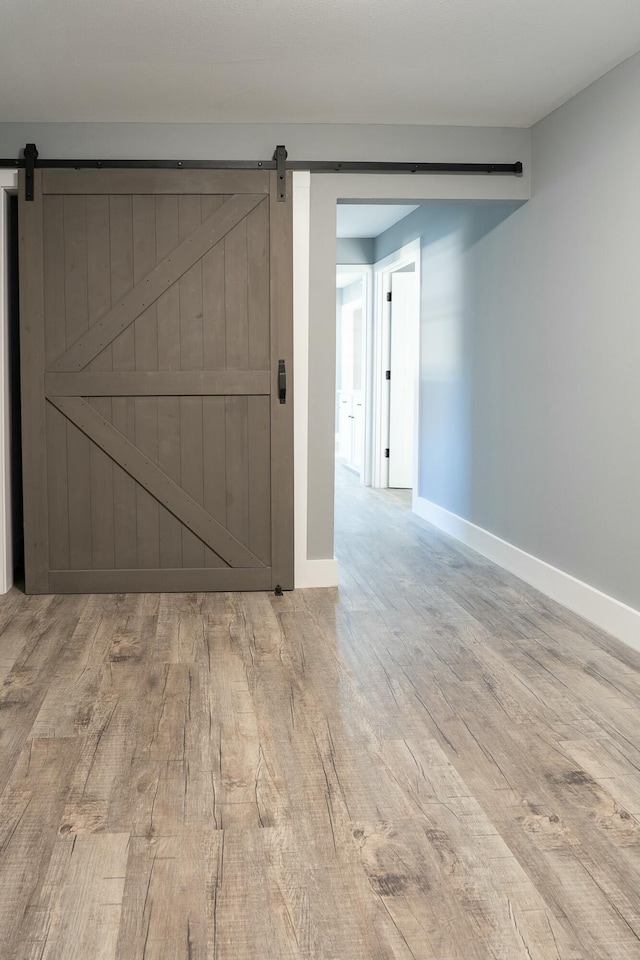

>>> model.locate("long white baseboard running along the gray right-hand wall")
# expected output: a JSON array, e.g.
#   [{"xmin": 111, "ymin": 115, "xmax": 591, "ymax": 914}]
[{"xmin": 413, "ymin": 496, "xmax": 640, "ymax": 650}]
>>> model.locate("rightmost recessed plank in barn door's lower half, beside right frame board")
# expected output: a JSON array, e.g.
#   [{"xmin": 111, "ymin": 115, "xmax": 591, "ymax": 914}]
[{"xmin": 247, "ymin": 397, "xmax": 271, "ymax": 565}]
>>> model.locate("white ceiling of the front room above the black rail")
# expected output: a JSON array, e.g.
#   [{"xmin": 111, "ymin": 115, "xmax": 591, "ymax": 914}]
[{"xmin": 0, "ymin": 0, "xmax": 640, "ymax": 126}]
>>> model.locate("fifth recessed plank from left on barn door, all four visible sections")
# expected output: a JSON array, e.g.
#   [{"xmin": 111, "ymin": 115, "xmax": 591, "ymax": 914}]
[{"xmin": 133, "ymin": 195, "xmax": 160, "ymax": 569}]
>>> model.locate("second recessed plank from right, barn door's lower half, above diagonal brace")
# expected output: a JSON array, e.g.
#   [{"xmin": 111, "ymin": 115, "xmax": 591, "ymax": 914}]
[{"xmin": 225, "ymin": 397, "xmax": 249, "ymax": 544}]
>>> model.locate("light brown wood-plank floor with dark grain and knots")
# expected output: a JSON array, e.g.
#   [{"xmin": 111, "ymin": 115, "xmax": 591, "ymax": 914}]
[{"xmin": 0, "ymin": 464, "xmax": 640, "ymax": 960}]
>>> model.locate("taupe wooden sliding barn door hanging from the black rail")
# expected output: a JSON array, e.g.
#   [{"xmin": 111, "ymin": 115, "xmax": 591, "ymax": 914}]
[{"xmin": 20, "ymin": 170, "xmax": 293, "ymax": 593}]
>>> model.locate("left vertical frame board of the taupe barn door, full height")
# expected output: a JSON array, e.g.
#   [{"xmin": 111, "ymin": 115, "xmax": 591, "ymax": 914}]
[{"xmin": 18, "ymin": 170, "xmax": 49, "ymax": 593}]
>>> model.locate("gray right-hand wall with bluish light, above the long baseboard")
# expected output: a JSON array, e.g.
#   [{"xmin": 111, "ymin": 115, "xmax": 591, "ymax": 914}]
[{"xmin": 416, "ymin": 55, "xmax": 640, "ymax": 608}]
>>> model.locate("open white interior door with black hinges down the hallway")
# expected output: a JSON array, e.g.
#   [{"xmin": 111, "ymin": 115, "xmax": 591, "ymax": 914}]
[{"xmin": 389, "ymin": 271, "xmax": 419, "ymax": 488}]
